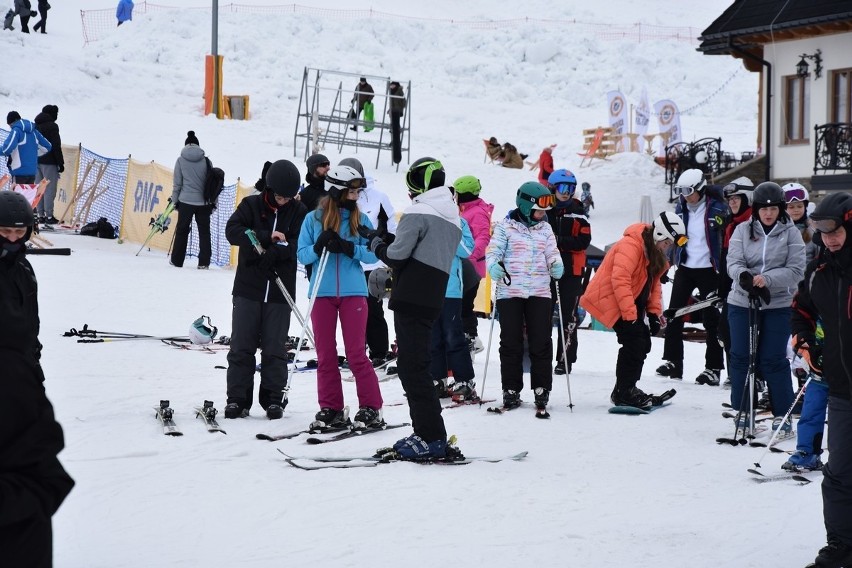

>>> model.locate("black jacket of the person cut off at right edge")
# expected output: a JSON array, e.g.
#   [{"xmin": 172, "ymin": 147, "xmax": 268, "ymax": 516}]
[{"xmin": 792, "ymin": 245, "xmax": 852, "ymax": 400}]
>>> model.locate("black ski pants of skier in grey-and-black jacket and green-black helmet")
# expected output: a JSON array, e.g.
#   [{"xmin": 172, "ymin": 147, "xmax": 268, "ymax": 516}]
[{"xmin": 393, "ymin": 312, "xmax": 447, "ymax": 442}]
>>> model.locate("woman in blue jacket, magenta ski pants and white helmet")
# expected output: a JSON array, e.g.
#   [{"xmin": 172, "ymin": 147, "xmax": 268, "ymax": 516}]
[{"xmin": 298, "ymin": 166, "xmax": 385, "ymax": 429}]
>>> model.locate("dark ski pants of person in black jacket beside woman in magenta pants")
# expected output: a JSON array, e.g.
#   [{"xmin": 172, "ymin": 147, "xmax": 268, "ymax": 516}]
[{"xmin": 228, "ymin": 296, "xmax": 290, "ymax": 410}]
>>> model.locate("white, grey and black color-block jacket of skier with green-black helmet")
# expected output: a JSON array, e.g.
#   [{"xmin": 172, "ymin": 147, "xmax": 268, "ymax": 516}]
[{"xmin": 376, "ymin": 186, "xmax": 462, "ymax": 320}]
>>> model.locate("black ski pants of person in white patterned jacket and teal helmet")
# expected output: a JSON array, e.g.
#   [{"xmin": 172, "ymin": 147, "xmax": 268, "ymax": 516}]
[{"xmin": 497, "ymin": 296, "xmax": 553, "ymax": 392}]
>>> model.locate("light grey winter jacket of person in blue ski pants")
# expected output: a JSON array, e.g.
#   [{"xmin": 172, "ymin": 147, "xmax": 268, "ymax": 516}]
[{"xmin": 728, "ymin": 219, "xmax": 805, "ymax": 310}]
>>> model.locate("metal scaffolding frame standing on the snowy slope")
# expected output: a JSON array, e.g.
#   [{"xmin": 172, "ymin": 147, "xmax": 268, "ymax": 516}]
[{"xmin": 293, "ymin": 67, "xmax": 411, "ymax": 170}]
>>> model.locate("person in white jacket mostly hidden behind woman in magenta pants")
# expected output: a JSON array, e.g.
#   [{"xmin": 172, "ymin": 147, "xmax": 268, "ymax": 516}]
[{"xmin": 340, "ymin": 158, "xmax": 396, "ymax": 367}]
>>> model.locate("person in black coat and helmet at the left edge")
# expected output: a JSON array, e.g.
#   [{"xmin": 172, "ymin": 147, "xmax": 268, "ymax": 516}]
[{"xmin": 0, "ymin": 191, "xmax": 74, "ymax": 568}]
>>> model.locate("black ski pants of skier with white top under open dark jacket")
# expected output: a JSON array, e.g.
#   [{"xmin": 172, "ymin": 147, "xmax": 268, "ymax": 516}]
[{"xmin": 663, "ymin": 266, "xmax": 725, "ymax": 369}]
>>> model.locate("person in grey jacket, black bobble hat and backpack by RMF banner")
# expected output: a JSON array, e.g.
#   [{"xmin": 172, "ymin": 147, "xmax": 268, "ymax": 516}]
[{"xmin": 169, "ymin": 130, "xmax": 214, "ymax": 270}]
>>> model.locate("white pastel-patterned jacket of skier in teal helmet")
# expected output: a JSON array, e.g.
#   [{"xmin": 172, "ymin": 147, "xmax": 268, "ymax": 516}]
[{"xmin": 485, "ymin": 209, "xmax": 562, "ymax": 300}]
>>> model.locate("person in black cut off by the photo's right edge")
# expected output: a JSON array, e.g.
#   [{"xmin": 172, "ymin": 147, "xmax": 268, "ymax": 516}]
[{"xmin": 792, "ymin": 192, "xmax": 852, "ymax": 568}]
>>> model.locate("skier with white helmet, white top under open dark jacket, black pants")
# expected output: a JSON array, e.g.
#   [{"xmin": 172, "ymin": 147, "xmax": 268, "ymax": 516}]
[{"xmin": 657, "ymin": 169, "xmax": 729, "ymax": 386}]
